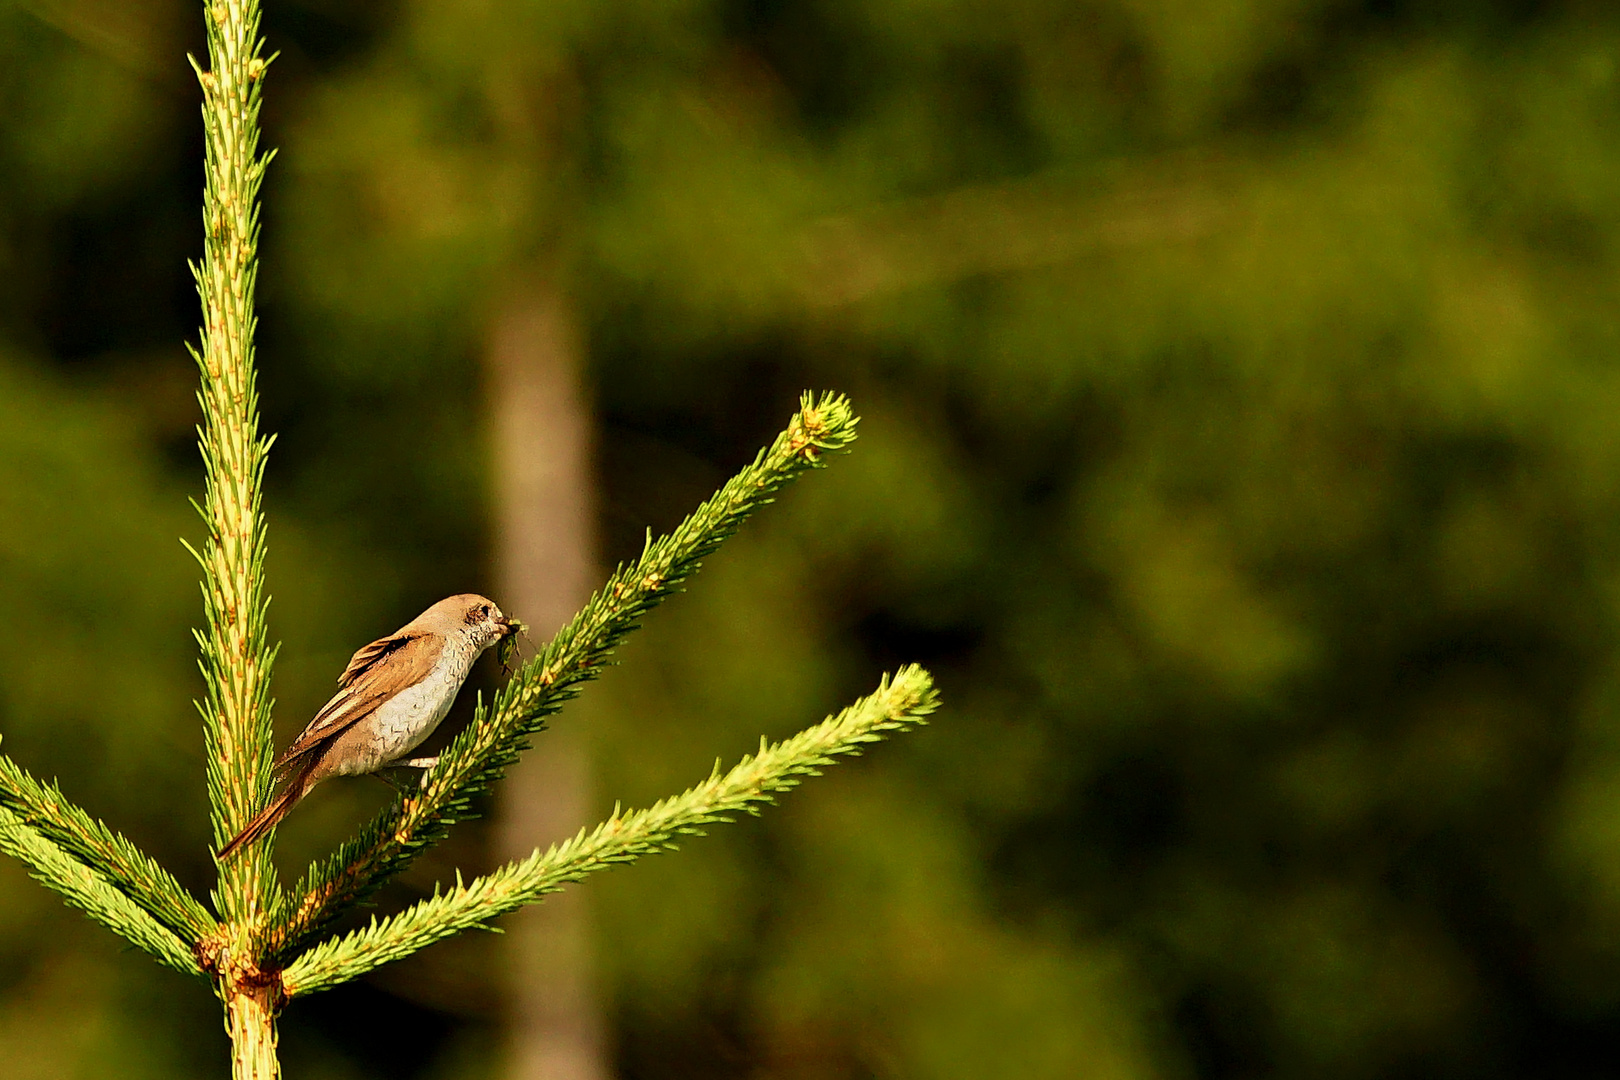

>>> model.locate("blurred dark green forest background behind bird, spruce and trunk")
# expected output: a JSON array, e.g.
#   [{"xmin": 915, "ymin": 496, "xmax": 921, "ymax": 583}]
[{"xmin": 9, "ymin": 0, "xmax": 1620, "ymax": 1080}]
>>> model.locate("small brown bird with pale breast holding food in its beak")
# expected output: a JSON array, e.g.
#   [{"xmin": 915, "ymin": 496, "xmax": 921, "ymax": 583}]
[{"xmin": 219, "ymin": 593, "xmax": 511, "ymax": 861}]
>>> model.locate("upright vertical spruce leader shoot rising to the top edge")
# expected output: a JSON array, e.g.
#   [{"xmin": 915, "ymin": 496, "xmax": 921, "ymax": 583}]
[{"xmin": 191, "ymin": 0, "xmax": 275, "ymax": 926}]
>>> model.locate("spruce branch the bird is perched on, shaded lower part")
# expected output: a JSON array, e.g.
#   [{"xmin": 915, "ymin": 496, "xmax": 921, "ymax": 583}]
[{"xmin": 262, "ymin": 393, "xmax": 857, "ymax": 957}]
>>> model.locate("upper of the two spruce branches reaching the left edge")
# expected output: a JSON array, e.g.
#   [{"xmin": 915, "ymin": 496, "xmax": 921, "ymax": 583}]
[{"xmin": 0, "ymin": 755, "xmax": 215, "ymax": 946}]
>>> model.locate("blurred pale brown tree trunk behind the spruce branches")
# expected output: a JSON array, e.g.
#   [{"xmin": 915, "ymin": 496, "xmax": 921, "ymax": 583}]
[{"xmin": 488, "ymin": 283, "xmax": 609, "ymax": 1080}]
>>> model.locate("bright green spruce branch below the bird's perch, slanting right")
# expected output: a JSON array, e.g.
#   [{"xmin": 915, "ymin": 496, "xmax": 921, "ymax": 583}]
[{"xmin": 282, "ymin": 665, "xmax": 938, "ymax": 997}]
